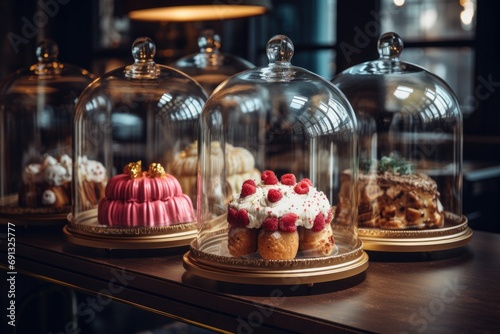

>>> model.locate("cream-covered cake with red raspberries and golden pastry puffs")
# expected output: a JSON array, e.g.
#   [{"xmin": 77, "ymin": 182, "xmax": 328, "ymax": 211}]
[{"xmin": 227, "ymin": 170, "xmax": 334, "ymax": 260}]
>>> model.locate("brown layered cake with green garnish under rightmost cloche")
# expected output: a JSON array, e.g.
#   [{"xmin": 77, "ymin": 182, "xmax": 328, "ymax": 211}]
[{"xmin": 335, "ymin": 157, "xmax": 444, "ymax": 229}]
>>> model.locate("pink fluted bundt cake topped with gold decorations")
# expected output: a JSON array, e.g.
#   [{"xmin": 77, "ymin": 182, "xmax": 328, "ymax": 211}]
[{"xmin": 98, "ymin": 161, "xmax": 195, "ymax": 227}]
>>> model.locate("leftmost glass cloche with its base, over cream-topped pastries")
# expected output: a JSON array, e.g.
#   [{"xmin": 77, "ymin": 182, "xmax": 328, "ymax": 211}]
[{"xmin": 0, "ymin": 40, "xmax": 94, "ymax": 225}]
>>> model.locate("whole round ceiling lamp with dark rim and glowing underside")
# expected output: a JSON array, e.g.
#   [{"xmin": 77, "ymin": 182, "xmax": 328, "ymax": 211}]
[{"xmin": 128, "ymin": 0, "xmax": 271, "ymax": 22}]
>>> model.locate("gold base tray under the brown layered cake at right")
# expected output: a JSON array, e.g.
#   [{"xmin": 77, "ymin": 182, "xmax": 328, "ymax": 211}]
[{"xmin": 358, "ymin": 212, "xmax": 473, "ymax": 252}]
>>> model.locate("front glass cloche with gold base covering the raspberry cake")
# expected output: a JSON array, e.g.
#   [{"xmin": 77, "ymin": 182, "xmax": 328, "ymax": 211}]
[{"xmin": 184, "ymin": 35, "xmax": 367, "ymax": 285}]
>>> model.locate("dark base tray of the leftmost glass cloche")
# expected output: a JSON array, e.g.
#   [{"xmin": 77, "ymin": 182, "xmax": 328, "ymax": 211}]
[{"xmin": 0, "ymin": 195, "xmax": 71, "ymax": 226}]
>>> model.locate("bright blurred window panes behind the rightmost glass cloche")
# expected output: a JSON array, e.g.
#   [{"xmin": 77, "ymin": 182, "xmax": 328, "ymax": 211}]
[{"xmin": 380, "ymin": 0, "xmax": 476, "ymax": 115}]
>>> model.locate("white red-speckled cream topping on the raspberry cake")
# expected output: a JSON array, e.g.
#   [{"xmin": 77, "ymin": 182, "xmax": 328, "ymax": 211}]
[{"xmin": 229, "ymin": 183, "xmax": 331, "ymax": 229}]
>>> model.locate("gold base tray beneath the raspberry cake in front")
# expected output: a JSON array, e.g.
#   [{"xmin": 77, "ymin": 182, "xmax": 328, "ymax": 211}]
[{"xmin": 183, "ymin": 233, "xmax": 368, "ymax": 285}]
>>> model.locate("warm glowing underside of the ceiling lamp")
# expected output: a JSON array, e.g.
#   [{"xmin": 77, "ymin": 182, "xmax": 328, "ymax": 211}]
[{"xmin": 129, "ymin": 4, "xmax": 266, "ymax": 22}]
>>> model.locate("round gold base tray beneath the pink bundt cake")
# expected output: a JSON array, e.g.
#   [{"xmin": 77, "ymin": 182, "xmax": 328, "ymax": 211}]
[{"xmin": 63, "ymin": 210, "xmax": 198, "ymax": 249}]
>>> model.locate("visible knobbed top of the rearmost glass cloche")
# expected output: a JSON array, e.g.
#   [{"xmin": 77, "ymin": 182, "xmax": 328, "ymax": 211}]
[{"xmin": 172, "ymin": 29, "xmax": 255, "ymax": 94}]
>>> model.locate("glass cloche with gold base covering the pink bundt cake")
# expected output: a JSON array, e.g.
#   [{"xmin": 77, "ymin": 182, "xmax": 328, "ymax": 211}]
[{"xmin": 65, "ymin": 37, "xmax": 207, "ymax": 248}]
